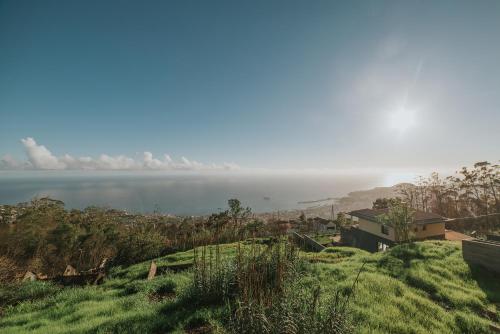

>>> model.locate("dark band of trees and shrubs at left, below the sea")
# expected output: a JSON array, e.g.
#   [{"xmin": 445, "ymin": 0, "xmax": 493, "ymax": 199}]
[{"xmin": 0, "ymin": 198, "xmax": 268, "ymax": 282}]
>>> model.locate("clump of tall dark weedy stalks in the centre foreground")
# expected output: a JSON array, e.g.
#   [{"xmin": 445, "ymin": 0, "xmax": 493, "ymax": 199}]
[{"xmin": 190, "ymin": 239, "xmax": 351, "ymax": 334}]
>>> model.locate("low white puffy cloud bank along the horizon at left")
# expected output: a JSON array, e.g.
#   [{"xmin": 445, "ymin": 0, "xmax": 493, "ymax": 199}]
[{"xmin": 0, "ymin": 137, "xmax": 240, "ymax": 171}]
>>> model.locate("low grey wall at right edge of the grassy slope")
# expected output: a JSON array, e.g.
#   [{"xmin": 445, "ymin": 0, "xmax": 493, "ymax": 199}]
[{"xmin": 462, "ymin": 239, "xmax": 500, "ymax": 273}]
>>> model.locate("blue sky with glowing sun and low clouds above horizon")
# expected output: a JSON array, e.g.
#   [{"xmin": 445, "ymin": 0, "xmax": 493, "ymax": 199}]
[{"xmin": 0, "ymin": 0, "xmax": 500, "ymax": 170}]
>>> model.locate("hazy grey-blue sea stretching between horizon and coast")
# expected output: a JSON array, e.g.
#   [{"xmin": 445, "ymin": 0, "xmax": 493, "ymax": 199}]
[{"xmin": 0, "ymin": 171, "xmax": 422, "ymax": 215}]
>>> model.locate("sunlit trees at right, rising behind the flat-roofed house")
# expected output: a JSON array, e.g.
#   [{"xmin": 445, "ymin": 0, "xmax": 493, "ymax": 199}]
[{"xmin": 373, "ymin": 161, "xmax": 500, "ymax": 237}]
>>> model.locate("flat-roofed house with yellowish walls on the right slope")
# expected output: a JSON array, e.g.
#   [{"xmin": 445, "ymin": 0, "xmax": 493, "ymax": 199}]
[{"xmin": 343, "ymin": 209, "xmax": 445, "ymax": 252}]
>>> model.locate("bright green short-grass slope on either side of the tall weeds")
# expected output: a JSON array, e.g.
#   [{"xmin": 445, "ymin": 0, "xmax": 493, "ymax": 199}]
[{"xmin": 0, "ymin": 241, "xmax": 500, "ymax": 334}]
